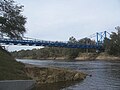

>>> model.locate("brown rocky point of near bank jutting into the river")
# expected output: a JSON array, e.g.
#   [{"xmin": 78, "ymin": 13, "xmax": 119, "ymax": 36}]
[{"xmin": 25, "ymin": 66, "xmax": 87, "ymax": 84}]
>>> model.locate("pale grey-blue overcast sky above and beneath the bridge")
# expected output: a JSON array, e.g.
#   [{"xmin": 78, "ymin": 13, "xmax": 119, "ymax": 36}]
[{"xmin": 8, "ymin": 0, "xmax": 120, "ymax": 50}]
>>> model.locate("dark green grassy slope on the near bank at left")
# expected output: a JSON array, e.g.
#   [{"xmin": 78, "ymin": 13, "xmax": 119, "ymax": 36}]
[{"xmin": 0, "ymin": 47, "xmax": 29, "ymax": 80}]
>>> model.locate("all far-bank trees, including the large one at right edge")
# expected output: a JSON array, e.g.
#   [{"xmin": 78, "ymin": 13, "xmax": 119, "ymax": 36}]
[{"xmin": 12, "ymin": 26, "xmax": 120, "ymax": 59}]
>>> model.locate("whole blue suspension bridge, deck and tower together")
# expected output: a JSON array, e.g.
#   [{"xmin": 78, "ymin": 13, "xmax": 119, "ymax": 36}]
[{"xmin": 0, "ymin": 31, "xmax": 108, "ymax": 50}]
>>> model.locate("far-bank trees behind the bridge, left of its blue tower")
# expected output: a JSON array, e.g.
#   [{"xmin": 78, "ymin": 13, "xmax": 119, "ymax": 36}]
[{"xmin": 12, "ymin": 36, "xmax": 96, "ymax": 59}]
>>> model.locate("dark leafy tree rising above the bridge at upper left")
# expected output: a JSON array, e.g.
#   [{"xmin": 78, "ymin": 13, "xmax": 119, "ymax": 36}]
[{"xmin": 0, "ymin": 0, "xmax": 26, "ymax": 39}]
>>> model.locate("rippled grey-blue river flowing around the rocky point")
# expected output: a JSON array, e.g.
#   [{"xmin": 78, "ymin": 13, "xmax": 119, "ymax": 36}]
[{"xmin": 17, "ymin": 59, "xmax": 120, "ymax": 90}]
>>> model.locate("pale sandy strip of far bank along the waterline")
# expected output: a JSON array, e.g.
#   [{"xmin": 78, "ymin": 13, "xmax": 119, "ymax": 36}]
[{"xmin": 19, "ymin": 52, "xmax": 120, "ymax": 61}]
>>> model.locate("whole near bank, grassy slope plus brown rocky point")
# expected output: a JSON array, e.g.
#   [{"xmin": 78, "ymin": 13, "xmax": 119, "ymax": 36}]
[{"xmin": 0, "ymin": 48, "xmax": 86, "ymax": 84}]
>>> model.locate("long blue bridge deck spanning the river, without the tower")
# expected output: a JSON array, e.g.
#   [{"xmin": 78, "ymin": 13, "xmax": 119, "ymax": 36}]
[{"xmin": 0, "ymin": 39, "xmax": 102, "ymax": 49}]
